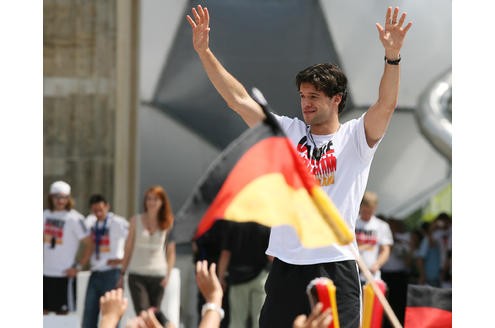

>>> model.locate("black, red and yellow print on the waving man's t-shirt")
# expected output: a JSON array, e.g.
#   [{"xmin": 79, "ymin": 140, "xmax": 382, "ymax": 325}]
[{"xmin": 297, "ymin": 136, "xmax": 337, "ymax": 186}]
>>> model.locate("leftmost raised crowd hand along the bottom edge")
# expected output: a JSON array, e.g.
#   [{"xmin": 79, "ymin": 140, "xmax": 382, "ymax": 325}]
[{"xmin": 99, "ymin": 288, "xmax": 128, "ymax": 328}]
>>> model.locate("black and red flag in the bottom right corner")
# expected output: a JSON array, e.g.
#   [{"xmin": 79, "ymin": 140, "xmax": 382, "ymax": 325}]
[{"xmin": 404, "ymin": 285, "xmax": 452, "ymax": 328}]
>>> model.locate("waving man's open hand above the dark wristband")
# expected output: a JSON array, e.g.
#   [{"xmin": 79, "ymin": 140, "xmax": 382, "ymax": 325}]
[{"xmin": 376, "ymin": 7, "xmax": 412, "ymax": 52}]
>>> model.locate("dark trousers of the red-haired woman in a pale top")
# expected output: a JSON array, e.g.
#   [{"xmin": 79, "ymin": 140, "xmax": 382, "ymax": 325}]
[{"xmin": 127, "ymin": 273, "xmax": 165, "ymax": 315}]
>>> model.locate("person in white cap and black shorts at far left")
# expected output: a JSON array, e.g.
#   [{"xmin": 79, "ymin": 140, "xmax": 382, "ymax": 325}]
[{"xmin": 43, "ymin": 181, "xmax": 91, "ymax": 314}]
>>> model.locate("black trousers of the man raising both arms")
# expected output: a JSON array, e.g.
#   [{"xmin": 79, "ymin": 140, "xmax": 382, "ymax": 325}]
[{"xmin": 259, "ymin": 258, "xmax": 361, "ymax": 328}]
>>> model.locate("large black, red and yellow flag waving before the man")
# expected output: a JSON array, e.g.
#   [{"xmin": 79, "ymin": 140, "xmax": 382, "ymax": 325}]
[{"xmin": 178, "ymin": 88, "xmax": 354, "ymax": 248}]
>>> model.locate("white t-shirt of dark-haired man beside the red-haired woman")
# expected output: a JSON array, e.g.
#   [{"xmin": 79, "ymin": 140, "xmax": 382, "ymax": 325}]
[{"xmin": 86, "ymin": 212, "xmax": 129, "ymax": 271}]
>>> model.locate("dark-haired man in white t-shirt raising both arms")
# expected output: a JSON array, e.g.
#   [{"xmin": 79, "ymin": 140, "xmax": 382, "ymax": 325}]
[{"xmin": 186, "ymin": 5, "xmax": 412, "ymax": 328}]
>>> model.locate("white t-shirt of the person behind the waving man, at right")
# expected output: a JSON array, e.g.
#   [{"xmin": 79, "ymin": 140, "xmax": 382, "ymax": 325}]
[{"xmin": 356, "ymin": 215, "xmax": 394, "ymax": 280}]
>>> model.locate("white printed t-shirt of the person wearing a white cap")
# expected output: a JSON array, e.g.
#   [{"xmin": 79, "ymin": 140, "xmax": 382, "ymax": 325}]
[{"xmin": 43, "ymin": 209, "xmax": 89, "ymax": 277}]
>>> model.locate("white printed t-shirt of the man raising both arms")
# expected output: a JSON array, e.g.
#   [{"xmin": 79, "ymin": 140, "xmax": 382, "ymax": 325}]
[{"xmin": 266, "ymin": 114, "xmax": 379, "ymax": 264}]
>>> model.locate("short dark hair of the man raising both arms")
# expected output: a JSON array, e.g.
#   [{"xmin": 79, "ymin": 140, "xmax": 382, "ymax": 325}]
[{"xmin": 296, "ymin": 63, "xmax": 347, "ymax": 114}]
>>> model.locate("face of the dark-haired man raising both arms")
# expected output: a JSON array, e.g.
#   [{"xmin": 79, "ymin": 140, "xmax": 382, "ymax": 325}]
[{"xmin": 299, "ymin": 82, "xmax": 338, "ymax": 126}]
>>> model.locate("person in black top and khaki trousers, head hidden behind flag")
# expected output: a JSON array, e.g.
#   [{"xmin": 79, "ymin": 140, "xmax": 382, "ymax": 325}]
[{"xmin": 218, "ymin": 222, "xmax": 272, "ymax": 328}]
